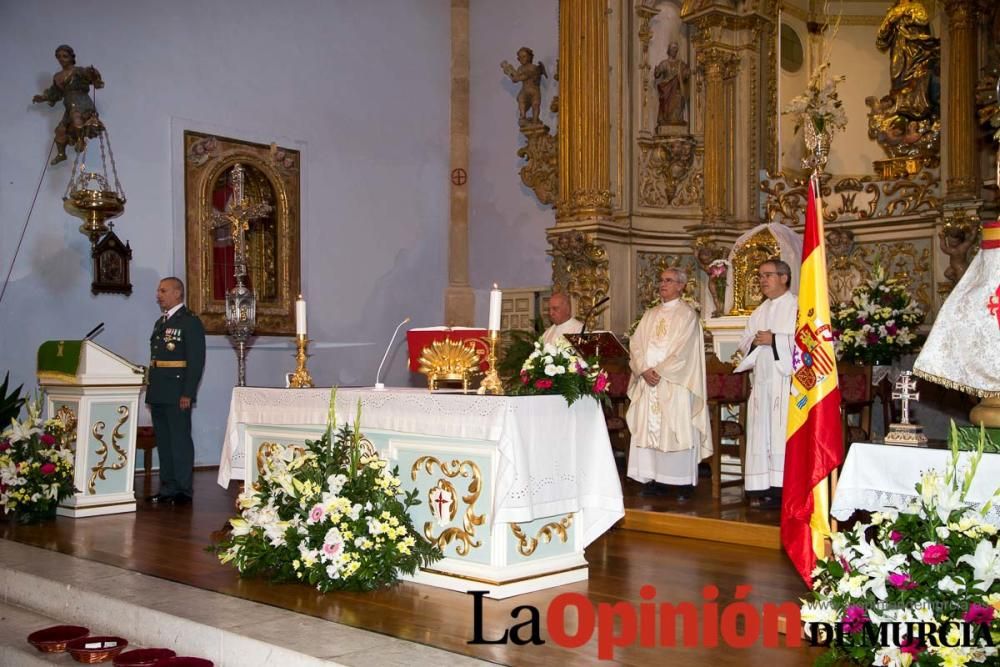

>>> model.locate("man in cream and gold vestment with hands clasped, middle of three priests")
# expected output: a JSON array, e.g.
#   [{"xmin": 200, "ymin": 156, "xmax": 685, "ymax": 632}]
[{"xmin": 625, "ymin": 269, "xmax": 712, "ymax": 500}]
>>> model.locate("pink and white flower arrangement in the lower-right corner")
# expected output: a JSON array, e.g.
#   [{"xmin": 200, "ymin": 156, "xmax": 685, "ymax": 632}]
[{"xmin": 801, "ymin": 423, "xmax": 1000, "ymax": 667}]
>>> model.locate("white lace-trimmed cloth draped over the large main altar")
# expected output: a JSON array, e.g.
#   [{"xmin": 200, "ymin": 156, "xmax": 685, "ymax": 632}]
[{"xmin": 218, "ymin": 387, "xmax": 625, "ymax": 544}]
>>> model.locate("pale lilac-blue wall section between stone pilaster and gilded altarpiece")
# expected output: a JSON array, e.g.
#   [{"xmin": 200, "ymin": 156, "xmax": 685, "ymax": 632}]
[{"xmin": 469, "ymin": 0, "xmax": 559, "ymax": 323}]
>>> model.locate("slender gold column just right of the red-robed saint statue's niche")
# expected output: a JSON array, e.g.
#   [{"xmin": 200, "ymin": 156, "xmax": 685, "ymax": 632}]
[{"xmin": 698, "ymin": 46, "xmax": 739, "ymax": 225}]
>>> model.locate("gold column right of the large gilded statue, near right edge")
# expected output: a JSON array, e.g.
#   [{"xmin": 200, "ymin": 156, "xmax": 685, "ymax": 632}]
[{"xmin": 944, "ymin": 0, "xmax": 980, "ymax": 200}]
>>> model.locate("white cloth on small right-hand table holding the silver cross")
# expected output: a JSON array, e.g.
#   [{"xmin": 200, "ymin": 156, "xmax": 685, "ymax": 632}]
[{"xmin": 830, "ymin": 442, "xmax": 1000, "ymax": 527}]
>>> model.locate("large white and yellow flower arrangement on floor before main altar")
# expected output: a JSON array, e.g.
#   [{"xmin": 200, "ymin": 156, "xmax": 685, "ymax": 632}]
[{"xmin": 215, "ymin": 390, "xmax": 442, "ymax": 592}]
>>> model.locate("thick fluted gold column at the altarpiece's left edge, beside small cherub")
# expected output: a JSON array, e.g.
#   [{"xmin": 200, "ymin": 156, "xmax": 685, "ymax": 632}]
[{"xmin": 556, "ymin": 0, "xmax": 611, "ymax": 226}]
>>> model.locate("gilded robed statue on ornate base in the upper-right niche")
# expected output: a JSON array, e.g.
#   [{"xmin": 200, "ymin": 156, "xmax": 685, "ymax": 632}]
[{"xmin": 865, "ymin": 0, "xmax": 941, "ymax": 157}]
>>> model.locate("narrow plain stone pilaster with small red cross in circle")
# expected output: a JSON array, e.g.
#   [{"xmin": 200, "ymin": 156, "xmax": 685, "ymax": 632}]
[{"xmin": 444, "ymin": 0, "xmax": 475, "ymax": 326}]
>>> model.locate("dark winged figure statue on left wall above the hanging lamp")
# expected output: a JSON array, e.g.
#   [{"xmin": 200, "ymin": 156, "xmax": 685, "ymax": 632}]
[{"xmin": 31, "ymin": 44, "xmax": 104, "ymax": 164}]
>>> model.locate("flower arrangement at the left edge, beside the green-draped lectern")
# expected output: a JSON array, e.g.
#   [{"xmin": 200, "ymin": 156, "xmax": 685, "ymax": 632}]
[{"xmin": 0, "ymin": 400, "xmax": 76, "ymax": 523}]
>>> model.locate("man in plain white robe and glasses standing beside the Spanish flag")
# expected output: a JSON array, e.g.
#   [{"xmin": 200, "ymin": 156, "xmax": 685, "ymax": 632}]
[{"xmin": 736, "ymin": 260, "xmax": 798, "ymax": 508}]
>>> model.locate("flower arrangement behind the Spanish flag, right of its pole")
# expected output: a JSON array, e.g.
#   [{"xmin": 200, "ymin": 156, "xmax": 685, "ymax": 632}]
[{"xmin": 832, "ymin": 265, "xmax": 925, "ymax": 364}]
